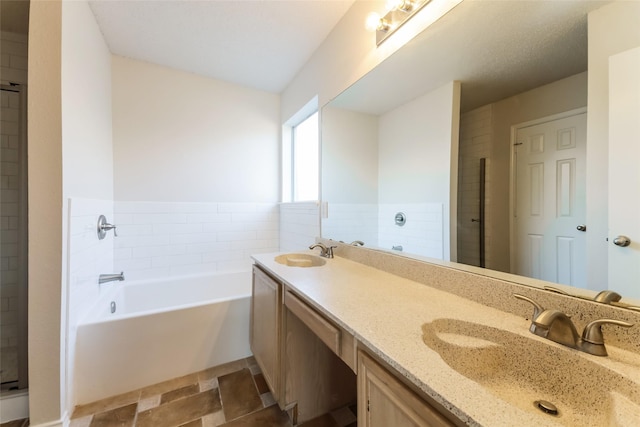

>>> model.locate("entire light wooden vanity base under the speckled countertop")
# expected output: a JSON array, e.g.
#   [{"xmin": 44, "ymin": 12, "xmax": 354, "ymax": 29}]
[{"xmin": 250, "ymin": 265, "xmax": 455, "ymax": 427}]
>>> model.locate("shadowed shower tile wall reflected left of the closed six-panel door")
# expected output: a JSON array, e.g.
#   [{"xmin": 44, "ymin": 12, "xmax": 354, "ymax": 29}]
[{"xmin": 458, "ymin": 105, "xmax": 493, "ymax": 266}]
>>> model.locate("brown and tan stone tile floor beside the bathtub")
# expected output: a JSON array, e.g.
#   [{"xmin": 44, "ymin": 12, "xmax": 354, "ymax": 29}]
[{"xmin": 2, "ymin": 357, "xmax": 357, "ymax": 427}]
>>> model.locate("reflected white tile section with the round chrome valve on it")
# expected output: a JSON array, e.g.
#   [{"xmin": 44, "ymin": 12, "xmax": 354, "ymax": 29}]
[{"xmin": 378, "ymin": 203, "xmax": 444, "ymax": 259}]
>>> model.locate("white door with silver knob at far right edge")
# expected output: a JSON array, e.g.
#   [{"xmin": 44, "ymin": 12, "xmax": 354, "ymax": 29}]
[{"xmin": 608, "ymin": 48, "xmax": 640, "ymax": 298}]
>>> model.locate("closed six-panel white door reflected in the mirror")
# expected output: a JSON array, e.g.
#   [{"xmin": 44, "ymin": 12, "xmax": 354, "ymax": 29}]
[{"xmin": 512, "ymin": 112, "xmax": 587, "ymax": 287}]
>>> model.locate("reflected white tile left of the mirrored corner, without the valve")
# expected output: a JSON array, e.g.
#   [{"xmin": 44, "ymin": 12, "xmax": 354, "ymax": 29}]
[{"xmin": 322, "ymin": 203, "xmax": 378, "ymax": 246}]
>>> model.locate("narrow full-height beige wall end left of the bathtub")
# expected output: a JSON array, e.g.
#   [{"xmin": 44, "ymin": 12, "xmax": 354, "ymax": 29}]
[{"xmin": 28, "ymin": 1, "xmax": 65, "ymax": 425}]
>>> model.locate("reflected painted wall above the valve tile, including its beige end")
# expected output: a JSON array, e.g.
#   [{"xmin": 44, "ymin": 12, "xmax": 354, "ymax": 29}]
[{"xmin": 378, "ymin": 82, "xmax": 460, "ymax": 260}]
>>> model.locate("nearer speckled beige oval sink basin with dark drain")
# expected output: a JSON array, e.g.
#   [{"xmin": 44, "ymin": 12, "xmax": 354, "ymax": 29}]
[{"xmin": 422, "ymin": 319, "xmax": 640, "ymax": 426}]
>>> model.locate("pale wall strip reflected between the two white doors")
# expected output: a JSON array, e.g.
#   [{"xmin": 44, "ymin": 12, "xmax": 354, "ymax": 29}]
[{"xmin": 587, "ymin": 1, "xmax": 640, "ymax": 289}]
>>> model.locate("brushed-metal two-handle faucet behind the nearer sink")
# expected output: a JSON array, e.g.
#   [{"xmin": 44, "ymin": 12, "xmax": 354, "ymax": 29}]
[{"xmin": 513, "ymin": 294, "xmax": 633, "ymax": 356}]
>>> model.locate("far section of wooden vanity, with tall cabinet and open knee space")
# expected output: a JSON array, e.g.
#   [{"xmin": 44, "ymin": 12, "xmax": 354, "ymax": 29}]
[{"xmin": 250, "ymin": 265, "xmax": 357, "ymax": 425}]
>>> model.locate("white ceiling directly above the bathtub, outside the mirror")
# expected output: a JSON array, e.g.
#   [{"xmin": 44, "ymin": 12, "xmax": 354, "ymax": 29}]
[{"xmin": 87, "ymin": 0, "xmax": 354, "ymax": 93}]
